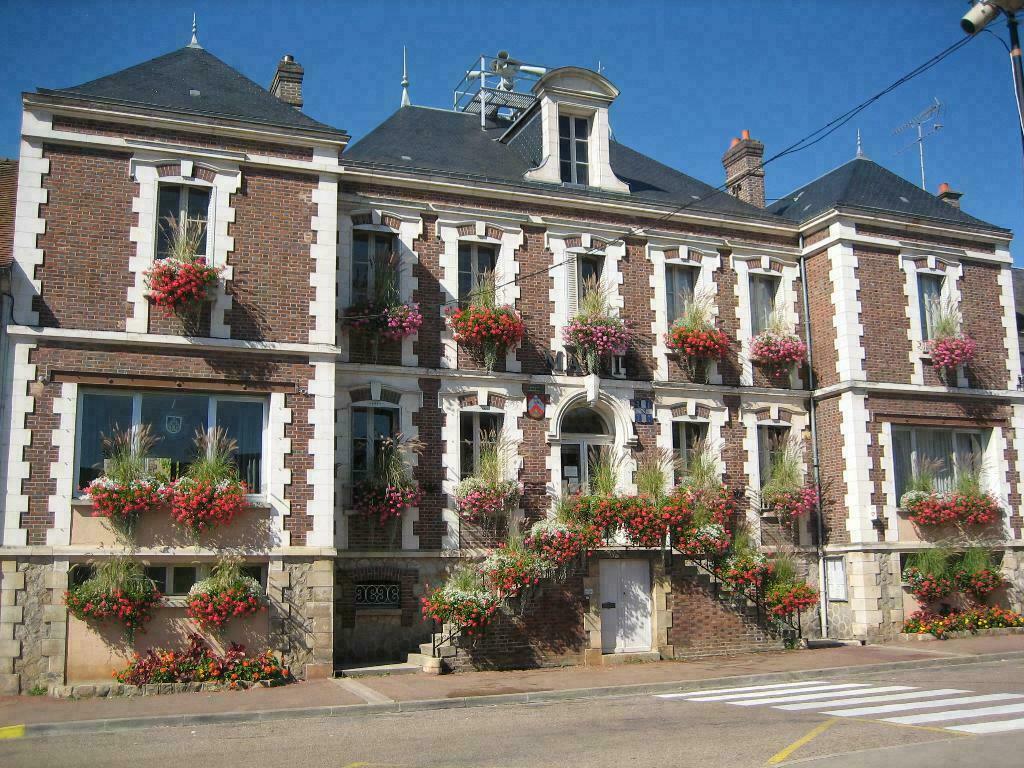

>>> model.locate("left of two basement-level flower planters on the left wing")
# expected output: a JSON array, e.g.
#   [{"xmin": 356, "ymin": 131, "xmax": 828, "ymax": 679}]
[{"xmin": 65, "ymin": 556, "xmax": 163, "ymax": 643}]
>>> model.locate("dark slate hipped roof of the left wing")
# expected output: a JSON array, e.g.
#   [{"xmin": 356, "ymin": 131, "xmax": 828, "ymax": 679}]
[{"xmin": 39, "ymin": 47, "xmax": 347, "ymax": 136}]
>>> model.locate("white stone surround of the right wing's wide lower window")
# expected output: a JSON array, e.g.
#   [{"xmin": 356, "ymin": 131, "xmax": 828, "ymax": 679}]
[{"xmin": 879, "ymin": 417, "xmax": 1022, "ymax": 542}]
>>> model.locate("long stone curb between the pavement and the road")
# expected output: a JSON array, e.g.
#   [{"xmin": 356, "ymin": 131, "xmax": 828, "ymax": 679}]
[{"xmin": 14, "ymin": 650, "xmax": 1024, "ymax": 737}]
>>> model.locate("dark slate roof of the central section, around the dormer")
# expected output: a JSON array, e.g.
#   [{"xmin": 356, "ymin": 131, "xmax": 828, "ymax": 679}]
[{"xmin": 342, "ymin": 106, "xmax": 778, "ymax": 223}]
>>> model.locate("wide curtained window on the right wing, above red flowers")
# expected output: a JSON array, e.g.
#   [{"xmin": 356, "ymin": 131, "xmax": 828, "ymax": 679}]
[{"xmin": 892, "ymin": 426, "xmax": 988, "ymax": 504}]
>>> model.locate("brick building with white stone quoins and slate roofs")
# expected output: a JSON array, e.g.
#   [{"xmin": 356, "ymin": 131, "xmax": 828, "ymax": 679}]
[{"xmin": 0, "ymin": 40, "xmax": 1024, "ymax": 691}]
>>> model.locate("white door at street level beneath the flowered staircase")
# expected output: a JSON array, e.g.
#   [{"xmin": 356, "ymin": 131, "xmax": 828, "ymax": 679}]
[{"xmin": 601, "ymin": 560, "xmax": 650, "ymax": 653}]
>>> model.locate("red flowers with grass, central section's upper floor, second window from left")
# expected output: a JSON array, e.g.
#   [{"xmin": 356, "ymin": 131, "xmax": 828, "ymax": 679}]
[{"xmin": 447, "ymin": 272, "xmax": 526, "ymax": 371}]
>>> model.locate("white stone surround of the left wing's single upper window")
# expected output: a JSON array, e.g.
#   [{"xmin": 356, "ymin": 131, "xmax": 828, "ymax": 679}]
[{"xmin": 125, "ymin": 152, "xmax": 242, "ymax": 339}]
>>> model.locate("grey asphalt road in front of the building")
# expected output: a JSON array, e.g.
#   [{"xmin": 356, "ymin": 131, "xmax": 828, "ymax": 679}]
[{"xmin": 0, "ymin": 662, "xmax": 1024, "ymax": 768}]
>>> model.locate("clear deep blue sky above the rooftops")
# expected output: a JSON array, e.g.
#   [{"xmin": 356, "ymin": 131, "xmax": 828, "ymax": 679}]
[{"xmin": 0, "ymin": 0, "xmax": 1024, "ymax": 263}]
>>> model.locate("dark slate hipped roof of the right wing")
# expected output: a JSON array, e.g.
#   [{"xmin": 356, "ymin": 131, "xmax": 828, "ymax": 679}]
[{"xmin": 767, "ymin": 158, "xmax": 1002, "ymax": 229}]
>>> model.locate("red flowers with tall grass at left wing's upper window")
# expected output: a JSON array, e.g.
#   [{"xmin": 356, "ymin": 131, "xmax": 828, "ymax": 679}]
[{"xmin": 144, "ymin": 216, "xmax": 222, "ymax": 332}]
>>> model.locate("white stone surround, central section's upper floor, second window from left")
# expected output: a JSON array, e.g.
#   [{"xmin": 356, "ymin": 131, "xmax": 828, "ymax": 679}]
[{"xmin": 437, "ymin": 218, "xmax": 523, "ymax": 373}]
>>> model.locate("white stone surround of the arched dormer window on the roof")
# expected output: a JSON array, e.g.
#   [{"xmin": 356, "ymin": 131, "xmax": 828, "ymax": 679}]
[{"xmin": 524, "ymin": 67, "xmax": 630, "ymax": 195}]
